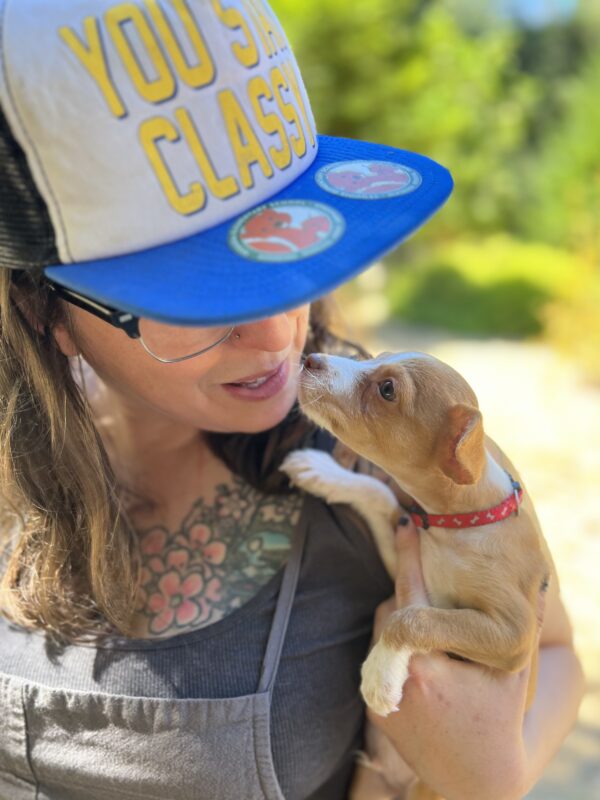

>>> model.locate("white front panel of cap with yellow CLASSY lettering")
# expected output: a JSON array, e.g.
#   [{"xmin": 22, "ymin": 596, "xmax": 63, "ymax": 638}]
[{"xmin": 0, "ymin": 0, "xmax": 316, "ymax": 262}]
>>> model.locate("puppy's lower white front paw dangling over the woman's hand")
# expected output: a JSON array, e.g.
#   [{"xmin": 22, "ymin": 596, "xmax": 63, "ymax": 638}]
[{"xmin": 360, "ymin": 642, "xmax": 412, "ymax": 717}]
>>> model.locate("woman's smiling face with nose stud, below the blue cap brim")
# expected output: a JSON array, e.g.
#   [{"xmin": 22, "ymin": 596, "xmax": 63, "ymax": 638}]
[{"xmin": 55, "ymin": 304, "xmax": 310, "ymax": 433}]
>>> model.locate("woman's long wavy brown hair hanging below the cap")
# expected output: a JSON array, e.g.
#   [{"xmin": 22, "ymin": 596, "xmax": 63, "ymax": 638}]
[{"xmin": 0, "ymin": 268, "xmax": 368, "ymax": 641}]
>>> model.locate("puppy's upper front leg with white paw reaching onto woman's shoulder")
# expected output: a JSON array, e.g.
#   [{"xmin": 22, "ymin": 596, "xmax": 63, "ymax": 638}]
[{"xmin": 280, "ymin": 448, "xmax": 400, "ymax": 577}]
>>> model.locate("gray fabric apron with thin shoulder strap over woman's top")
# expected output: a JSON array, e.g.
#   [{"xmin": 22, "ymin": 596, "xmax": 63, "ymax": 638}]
[{"xmin": 0, "ymin": 497, "xmax": 312, "ymax": 800}]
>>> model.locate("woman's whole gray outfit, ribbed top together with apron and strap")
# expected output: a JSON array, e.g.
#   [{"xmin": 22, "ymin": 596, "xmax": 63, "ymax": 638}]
[{"xmin": 0, "ymin": 434, "xmax": 393, "ymax": 800}]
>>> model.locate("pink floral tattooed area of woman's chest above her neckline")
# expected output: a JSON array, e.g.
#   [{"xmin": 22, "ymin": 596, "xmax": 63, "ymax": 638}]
[{"xmin": 129, "ymin": 478, "xmax": 302, "ymax": 638}]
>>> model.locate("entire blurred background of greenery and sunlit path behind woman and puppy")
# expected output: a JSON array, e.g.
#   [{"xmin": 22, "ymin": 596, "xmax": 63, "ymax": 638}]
[{"xmin": 271, "ymin": 0, "xmax": 600, "ymax": 800}]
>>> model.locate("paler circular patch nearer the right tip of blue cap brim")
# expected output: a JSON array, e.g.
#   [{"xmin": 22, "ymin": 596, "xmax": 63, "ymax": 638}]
[{"xmin": 315, "ymin": 161, "xmax": 423, "ymax": 200}]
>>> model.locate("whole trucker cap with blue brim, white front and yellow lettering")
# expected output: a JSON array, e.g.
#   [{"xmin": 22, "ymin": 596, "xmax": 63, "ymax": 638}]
[{"xmin": 0, "ymin": 0, "xmax": 452, "ymax": 325}]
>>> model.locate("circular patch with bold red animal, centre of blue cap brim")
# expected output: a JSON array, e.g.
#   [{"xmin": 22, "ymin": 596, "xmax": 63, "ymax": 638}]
[{"xmin": 228, "ymin": 200, "xmax": 346, "ymax": 261}]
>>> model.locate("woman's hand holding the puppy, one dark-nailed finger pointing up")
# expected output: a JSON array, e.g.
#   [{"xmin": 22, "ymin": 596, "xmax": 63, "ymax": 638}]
[{"xmin": 368, "ymin": 519, "xmax": 540, "ymax": 800}]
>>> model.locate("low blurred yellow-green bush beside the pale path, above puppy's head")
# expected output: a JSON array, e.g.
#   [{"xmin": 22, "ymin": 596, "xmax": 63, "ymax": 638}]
[{"xmin": 387, "ymin": 234, "xmax": 585, "ymax": 338}]
